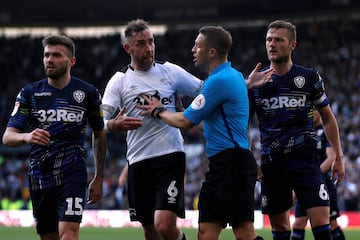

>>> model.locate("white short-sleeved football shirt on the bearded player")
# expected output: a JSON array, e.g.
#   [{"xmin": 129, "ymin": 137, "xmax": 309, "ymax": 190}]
[{"xmin": 102, "ymin": 62, "xmax": 202, "ymax": 164}]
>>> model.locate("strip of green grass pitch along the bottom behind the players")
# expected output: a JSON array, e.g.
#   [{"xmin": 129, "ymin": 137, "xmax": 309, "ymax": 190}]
[{"xmin": 0, "ymin": 226, "xmax": 360, "ymax": 240}]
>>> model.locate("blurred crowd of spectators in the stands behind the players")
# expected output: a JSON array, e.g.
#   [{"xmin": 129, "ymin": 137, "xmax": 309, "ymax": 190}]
[{"xmin": 0, "ymin": 16, "xmax": 360, "ymax": 211}]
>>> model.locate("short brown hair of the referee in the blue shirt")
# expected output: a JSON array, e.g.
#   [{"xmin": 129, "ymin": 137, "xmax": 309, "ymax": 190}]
[{"xmin": 199, "ymin": 26, "xmax": 232, "ymax": 55}]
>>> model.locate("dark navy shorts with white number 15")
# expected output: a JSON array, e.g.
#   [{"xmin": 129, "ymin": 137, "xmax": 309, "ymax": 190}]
[{"xmin": 30, "ymin": 181, "xmax": 86, "ymax": 234}]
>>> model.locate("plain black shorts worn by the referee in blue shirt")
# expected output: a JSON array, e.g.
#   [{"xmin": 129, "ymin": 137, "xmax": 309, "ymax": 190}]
[{"xmin": 199, "ymin": 148, "xmax": 257, "ymax": 227}]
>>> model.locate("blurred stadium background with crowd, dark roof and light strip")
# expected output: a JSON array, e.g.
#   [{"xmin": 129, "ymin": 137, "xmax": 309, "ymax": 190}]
[{"xmin": 0, "ymin": 0, "xmax": 360, "ymax": 214}]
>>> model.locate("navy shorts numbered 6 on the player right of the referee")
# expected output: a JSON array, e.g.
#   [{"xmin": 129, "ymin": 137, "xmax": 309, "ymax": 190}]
[{"xmin": 261, "ymin": 145, "xmax": 329, "ymax": 215}]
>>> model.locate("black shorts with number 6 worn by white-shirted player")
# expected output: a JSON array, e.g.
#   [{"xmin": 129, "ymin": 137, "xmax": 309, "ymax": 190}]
[{"xmin": 128, "ymin": 152, "xmax": 186, "ymax": 224}]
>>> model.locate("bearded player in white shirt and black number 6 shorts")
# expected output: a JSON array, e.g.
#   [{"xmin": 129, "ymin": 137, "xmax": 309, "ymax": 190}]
[{"xmin": 102, "ymin": 19, "xmax": 202, "ymax": 240}]
